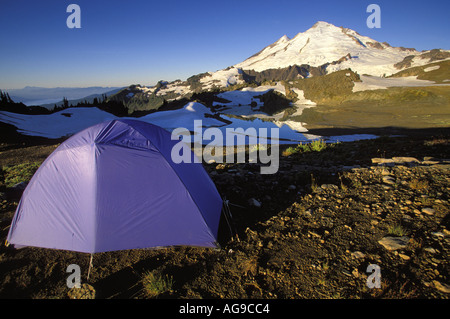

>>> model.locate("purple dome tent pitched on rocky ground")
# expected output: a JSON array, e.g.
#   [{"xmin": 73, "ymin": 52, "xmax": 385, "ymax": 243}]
[{"xmin": 7, "ymin": 120, "xmax": 223, "ymax": 253}]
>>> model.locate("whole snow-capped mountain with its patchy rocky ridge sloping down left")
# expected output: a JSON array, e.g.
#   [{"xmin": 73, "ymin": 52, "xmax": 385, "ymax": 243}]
[{"xmin": 115, "ymin": 21, "xmax": 450, "ymax": 104}]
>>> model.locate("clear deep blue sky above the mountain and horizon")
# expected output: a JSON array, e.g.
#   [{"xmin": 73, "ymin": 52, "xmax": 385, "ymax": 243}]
[{"xmin": 0, "ymin": 0, "xmax": 450, "ymax": 89}]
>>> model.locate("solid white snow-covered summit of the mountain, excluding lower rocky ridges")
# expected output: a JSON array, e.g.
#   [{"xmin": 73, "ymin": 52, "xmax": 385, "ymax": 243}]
[{"xmin": 234, "ymin": 21, "xmax": 419, "ymax": 76}]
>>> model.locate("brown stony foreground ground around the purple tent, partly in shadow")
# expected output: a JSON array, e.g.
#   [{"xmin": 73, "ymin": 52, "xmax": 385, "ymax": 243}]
[{"xmin": 0, "ymin": 131, "xmax": 450, "ymax": 299}]
